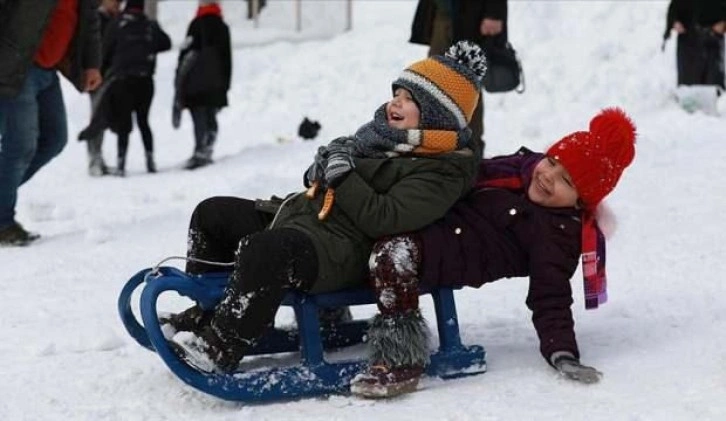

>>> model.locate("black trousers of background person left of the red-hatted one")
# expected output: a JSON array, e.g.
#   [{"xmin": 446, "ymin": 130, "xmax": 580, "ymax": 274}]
[{"xmin": 110, "ymin": 76, "xmax": 154, "ymax": 158}]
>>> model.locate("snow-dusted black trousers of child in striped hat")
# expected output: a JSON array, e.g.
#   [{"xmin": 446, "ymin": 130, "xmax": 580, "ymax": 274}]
[{"xmin": 187, "ymin": 197, "xmax": 318, "ymax": 359}]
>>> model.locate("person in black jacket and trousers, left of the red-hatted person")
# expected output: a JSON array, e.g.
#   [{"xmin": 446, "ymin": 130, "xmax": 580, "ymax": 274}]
[{"xmin": 103, "ymin": 0, "xmax": 171, "ymax": 177}]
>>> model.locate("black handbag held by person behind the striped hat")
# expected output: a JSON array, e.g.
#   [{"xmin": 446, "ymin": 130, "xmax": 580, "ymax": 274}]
[{"xmin": 483, "ymin": 41, "xmax": 525, "ymax": 94}]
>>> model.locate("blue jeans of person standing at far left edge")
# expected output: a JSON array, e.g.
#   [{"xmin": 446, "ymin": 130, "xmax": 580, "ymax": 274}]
[{"xmin": 0, "ymin": 66, "xmax": 68, "ymax": 228}]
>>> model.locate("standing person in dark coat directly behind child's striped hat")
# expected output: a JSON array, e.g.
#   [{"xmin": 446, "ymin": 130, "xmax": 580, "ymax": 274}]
[{"xmin": 409, "ymin": 0, "xmax": 508, "ymax": 150}]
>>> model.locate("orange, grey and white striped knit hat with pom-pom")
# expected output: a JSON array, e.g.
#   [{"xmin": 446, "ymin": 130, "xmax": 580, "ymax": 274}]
[{"xmin": 393, "ymin": 41, "xmax": 487, "ymax": 131}]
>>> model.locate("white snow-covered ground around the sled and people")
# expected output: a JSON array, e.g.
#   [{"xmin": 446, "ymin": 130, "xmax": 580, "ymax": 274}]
[{"xmin": 0, "ymin": 0, "xmax": 726, "ymax": 421}]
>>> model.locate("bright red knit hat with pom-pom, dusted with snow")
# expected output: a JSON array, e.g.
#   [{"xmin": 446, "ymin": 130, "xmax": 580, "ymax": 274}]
[{"xmin": 546, "ymin": 108, "xmax": 635, "ymax": 212}]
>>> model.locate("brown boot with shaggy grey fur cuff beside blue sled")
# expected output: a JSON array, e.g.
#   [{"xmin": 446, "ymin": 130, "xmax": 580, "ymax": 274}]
[{"xmin": 350, "ymin": 310, "xmax": 429, "ymax": 399}]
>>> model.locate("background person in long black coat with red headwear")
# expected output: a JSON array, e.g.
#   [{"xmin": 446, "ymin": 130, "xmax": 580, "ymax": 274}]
[{"xmin": 173, "ymin": 0, "xmax": 232, "ymax": 169}]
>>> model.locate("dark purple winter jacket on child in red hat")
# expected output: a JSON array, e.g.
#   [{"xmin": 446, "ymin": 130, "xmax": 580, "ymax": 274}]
[{"xmin": 419, "ymin": 148, "xmax": 581, "ymax": 363}]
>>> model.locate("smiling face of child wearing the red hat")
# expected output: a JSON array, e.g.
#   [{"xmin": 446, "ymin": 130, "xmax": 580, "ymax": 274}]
[{"xmin": 527, "ymin": 156, "xmax": 579, "ymax": 208}]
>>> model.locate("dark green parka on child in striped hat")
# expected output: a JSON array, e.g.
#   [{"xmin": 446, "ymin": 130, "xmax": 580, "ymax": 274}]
[{"xmin": 274, "ymin": 149, "xmax": 480, "ymax": 293}]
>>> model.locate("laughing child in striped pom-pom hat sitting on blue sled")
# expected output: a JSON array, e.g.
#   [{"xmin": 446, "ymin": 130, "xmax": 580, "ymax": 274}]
[{"xmin": 165, "ymin": 43, "xmax": 485, "ymax": 378}]
